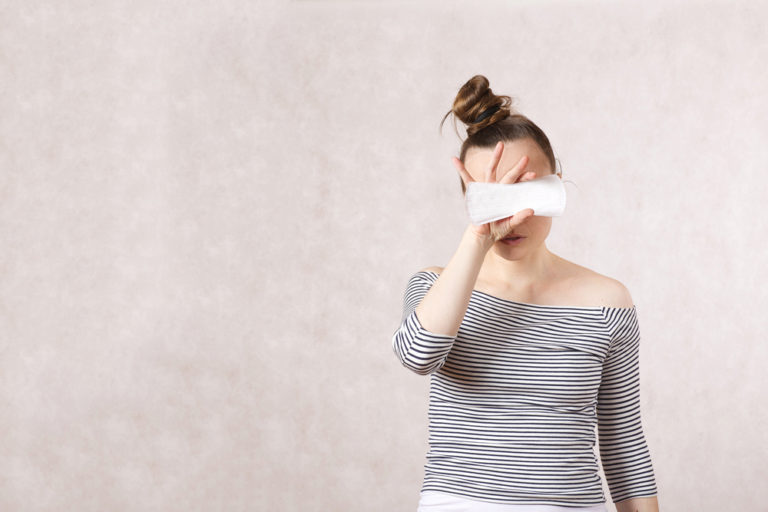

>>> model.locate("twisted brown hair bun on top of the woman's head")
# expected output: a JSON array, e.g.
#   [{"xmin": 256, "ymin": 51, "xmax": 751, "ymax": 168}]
[{"xmin": 440, "ymin": 75, "xmax": 512, "ymax": 136}]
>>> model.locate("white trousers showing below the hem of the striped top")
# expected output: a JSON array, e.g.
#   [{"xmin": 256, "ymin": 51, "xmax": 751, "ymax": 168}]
[{"xmin": 416, "ymin": 491, "xmax": 608, "ymax": 512}]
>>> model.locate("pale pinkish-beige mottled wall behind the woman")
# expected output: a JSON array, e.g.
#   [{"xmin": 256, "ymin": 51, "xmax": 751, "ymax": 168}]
[{"xmin": 0, "ymin": 0, "xmax": 768, "ymax": 512}]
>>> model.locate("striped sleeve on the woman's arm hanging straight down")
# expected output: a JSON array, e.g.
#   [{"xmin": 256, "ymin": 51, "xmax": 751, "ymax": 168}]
[{"xmin": 597, "ymin": 306, "xmax": 657, "ymax": 502}]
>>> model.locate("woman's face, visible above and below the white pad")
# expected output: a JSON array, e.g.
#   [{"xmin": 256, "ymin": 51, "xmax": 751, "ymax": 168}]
[{"xmin": 464, "ymin": 138, "xmax": 562, "ymax": 259}]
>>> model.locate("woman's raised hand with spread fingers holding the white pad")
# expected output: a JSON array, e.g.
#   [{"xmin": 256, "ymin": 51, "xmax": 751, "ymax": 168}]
[{"xmin": 451, "ymin": 141, "xmax": 536, "ymax": 248}]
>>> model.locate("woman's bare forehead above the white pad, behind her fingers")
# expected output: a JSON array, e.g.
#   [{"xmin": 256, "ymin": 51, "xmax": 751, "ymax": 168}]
[{"xmin": 464, "ymin": 137, "xmax": 552, "ymax": 180}]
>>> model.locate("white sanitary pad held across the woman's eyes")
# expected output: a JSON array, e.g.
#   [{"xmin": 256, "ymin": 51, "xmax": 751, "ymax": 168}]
[{"xmin": 466, "ymin": 174, "xmax": 565, "ymax": 226}]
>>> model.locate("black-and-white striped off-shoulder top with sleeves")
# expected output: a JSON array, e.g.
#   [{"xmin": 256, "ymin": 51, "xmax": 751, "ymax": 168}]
[{"xmin": 392, "ymin": 271, "xmax": 657, "ymax": 507}]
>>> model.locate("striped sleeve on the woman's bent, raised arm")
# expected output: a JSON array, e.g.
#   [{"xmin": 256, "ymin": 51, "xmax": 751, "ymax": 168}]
[{"xmin": 392, "ymin": 272, "xmax": 456, "ymax": 375}]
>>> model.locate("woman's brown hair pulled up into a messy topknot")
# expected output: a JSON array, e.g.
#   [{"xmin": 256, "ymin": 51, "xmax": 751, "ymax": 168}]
[{"xmin": 440, "ymin": 75, "xmax": 557, "ymax": 193}]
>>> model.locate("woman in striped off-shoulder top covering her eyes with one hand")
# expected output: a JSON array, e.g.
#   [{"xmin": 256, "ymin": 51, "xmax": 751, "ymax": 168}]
[{"xmin": 392, "ymin": 75, "xmax": 658, "ymax": 512}]
